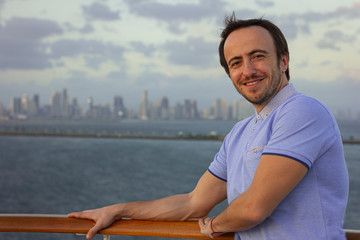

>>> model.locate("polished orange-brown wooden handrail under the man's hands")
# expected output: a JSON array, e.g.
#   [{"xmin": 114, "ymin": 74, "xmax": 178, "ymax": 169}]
[{"xmin": 0, "ymin": 214, "xmax": 360, "ymax": 240}]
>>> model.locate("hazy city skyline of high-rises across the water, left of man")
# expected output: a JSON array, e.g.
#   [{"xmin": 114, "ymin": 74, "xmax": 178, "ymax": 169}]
[{"xmin": 0, "ymin": 88, "xmax": 255, "ymax": 120}]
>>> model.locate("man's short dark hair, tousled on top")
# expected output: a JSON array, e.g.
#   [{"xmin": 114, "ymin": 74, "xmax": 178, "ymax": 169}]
[{"xmin": 219, "ymin": 13, "xmax": 290, "ymax": 80}]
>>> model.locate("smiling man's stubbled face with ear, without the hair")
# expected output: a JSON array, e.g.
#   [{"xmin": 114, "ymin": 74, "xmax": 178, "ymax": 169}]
[{"xmin": 224, "ymin": 26, "xmax": 288, "ymax": 112}]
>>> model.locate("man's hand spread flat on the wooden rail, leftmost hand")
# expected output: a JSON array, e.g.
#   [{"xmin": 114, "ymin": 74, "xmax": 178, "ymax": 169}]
[{"xmin": 68, "ymin": 206, "xmax": 116, "ymax": 239}]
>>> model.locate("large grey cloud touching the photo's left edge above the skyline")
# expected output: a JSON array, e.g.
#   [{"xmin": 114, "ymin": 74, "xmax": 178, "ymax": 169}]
[{"xmin": 0, "ymin": 17, "xmax": 63, "ymax": 70}]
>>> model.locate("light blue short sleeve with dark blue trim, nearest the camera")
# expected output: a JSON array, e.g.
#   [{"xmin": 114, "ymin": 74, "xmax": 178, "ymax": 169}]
[{"xmin": 263, "ymin": 95, "xmax": 340, "ymax": 168}]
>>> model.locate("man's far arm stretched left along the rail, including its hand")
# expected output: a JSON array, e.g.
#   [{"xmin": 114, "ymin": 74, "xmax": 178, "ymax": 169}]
[{"xmin": 68, "ymin": 171, "xmax": 226, "ymax": 239}]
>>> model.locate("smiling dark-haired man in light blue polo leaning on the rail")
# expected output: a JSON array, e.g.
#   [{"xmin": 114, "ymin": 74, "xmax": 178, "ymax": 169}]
[{"xmin": 69, "ymin": 15, "xmax": 348, "ymax": 240}]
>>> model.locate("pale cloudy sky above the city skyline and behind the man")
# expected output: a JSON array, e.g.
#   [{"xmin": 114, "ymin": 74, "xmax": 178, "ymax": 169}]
[{"xmin": 0, "ymin": 0, "xmax": 360, "ymax": 115}]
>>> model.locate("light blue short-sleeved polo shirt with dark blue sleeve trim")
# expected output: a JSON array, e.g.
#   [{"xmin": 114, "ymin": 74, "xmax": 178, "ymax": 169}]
[{"xmin": 208, "ymin": 84, "xmax": 349, "ymax": 240}]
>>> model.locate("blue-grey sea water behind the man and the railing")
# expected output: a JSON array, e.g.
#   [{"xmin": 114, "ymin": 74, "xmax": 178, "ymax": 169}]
[{"xmin": 0, "ymin": 121, "xmax": 360, "ymax": 240}]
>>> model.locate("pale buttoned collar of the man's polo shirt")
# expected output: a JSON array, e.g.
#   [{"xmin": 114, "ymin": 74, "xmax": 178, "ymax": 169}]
[{"xmin": 255, "ymin": 83, "xmax": 297, "ymax": 122}]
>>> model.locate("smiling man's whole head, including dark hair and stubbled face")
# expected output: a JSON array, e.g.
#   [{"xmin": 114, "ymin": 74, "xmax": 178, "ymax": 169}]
[{"xmin": 219, "ymin": 16, "xmax": 289, "ymax": 112}]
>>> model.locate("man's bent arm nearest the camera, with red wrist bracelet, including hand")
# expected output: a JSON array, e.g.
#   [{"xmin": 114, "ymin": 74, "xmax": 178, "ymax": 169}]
[{"xmin": 199, "ymin": 155, "xmax": 308, "ymax": 235}]
